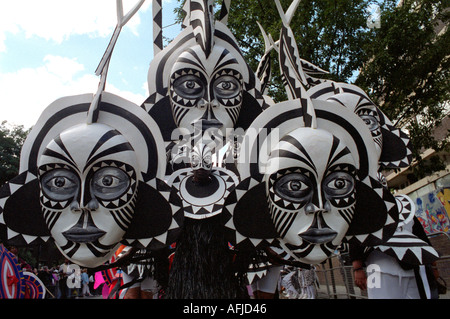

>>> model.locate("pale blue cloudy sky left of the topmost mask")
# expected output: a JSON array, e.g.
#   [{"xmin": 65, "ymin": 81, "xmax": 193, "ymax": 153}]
[{"xmin": 0, "ymin": 0, "xmax": 181, "ymax": 129}]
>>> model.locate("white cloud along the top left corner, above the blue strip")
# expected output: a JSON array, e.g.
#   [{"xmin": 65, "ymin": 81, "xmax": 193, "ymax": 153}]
[{"xmin": 0, "ymin": 0, "xmax": 151, "ymax": 52}]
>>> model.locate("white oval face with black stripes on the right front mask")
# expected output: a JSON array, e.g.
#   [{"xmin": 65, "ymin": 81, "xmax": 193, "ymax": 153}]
[{"xmin": 265, "ymin": 128, "xmax": 356, "ymax": 264}]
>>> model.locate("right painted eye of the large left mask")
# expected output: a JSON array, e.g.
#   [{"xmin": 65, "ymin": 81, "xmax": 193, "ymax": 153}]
[{"xmin": 91, "ymin": 167, "xmax": 130, "ymax": 200}]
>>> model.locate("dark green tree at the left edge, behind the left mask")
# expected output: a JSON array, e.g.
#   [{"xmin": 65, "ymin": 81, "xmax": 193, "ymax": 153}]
[{"xmin": 0, "ymin": 121, "xmax": 30, "ymax": 186}]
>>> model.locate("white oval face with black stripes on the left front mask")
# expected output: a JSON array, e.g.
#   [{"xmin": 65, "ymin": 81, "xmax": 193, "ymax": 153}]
[{"xmin": 38, "ymin": 123, "xmax": 140, "ymax": 267}]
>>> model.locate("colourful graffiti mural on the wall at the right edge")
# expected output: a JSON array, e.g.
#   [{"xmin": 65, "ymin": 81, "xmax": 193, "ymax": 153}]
[{"xmin": 415, "ymin": 188, "xmax": 450, "ymax": 234}]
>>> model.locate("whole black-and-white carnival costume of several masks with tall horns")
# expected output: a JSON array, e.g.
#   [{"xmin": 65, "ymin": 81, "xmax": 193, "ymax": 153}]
[{"xmin": 0, "ymin": 0, "xmax": 436, "ymax": 298}]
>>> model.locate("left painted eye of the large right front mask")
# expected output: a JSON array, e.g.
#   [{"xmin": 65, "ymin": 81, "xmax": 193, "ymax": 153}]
[{"xmin": 274, "ymin": 173, "xmax": 313, "ymax": 203}]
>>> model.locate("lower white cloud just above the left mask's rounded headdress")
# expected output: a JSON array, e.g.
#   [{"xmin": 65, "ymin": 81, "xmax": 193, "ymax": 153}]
[{"xmin": 0, "ymin": 55, "xmax": 145, "ymax": 128}]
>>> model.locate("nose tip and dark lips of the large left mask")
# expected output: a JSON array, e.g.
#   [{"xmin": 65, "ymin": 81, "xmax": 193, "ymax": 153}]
[{"xmin": 62, "ymin": 210, "xmax": 106, "ymax": 244}]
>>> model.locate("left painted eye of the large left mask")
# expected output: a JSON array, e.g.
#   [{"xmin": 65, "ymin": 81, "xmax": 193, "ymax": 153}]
[{"xmin": 41, "ymin": 169, "xmax": 80, "ymax": 201}]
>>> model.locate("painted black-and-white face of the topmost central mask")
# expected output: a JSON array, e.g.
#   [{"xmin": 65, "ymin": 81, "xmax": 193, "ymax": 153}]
[{"xmin": 169, "ymin": 46, "xmax": 243, "ymax": 136}]
